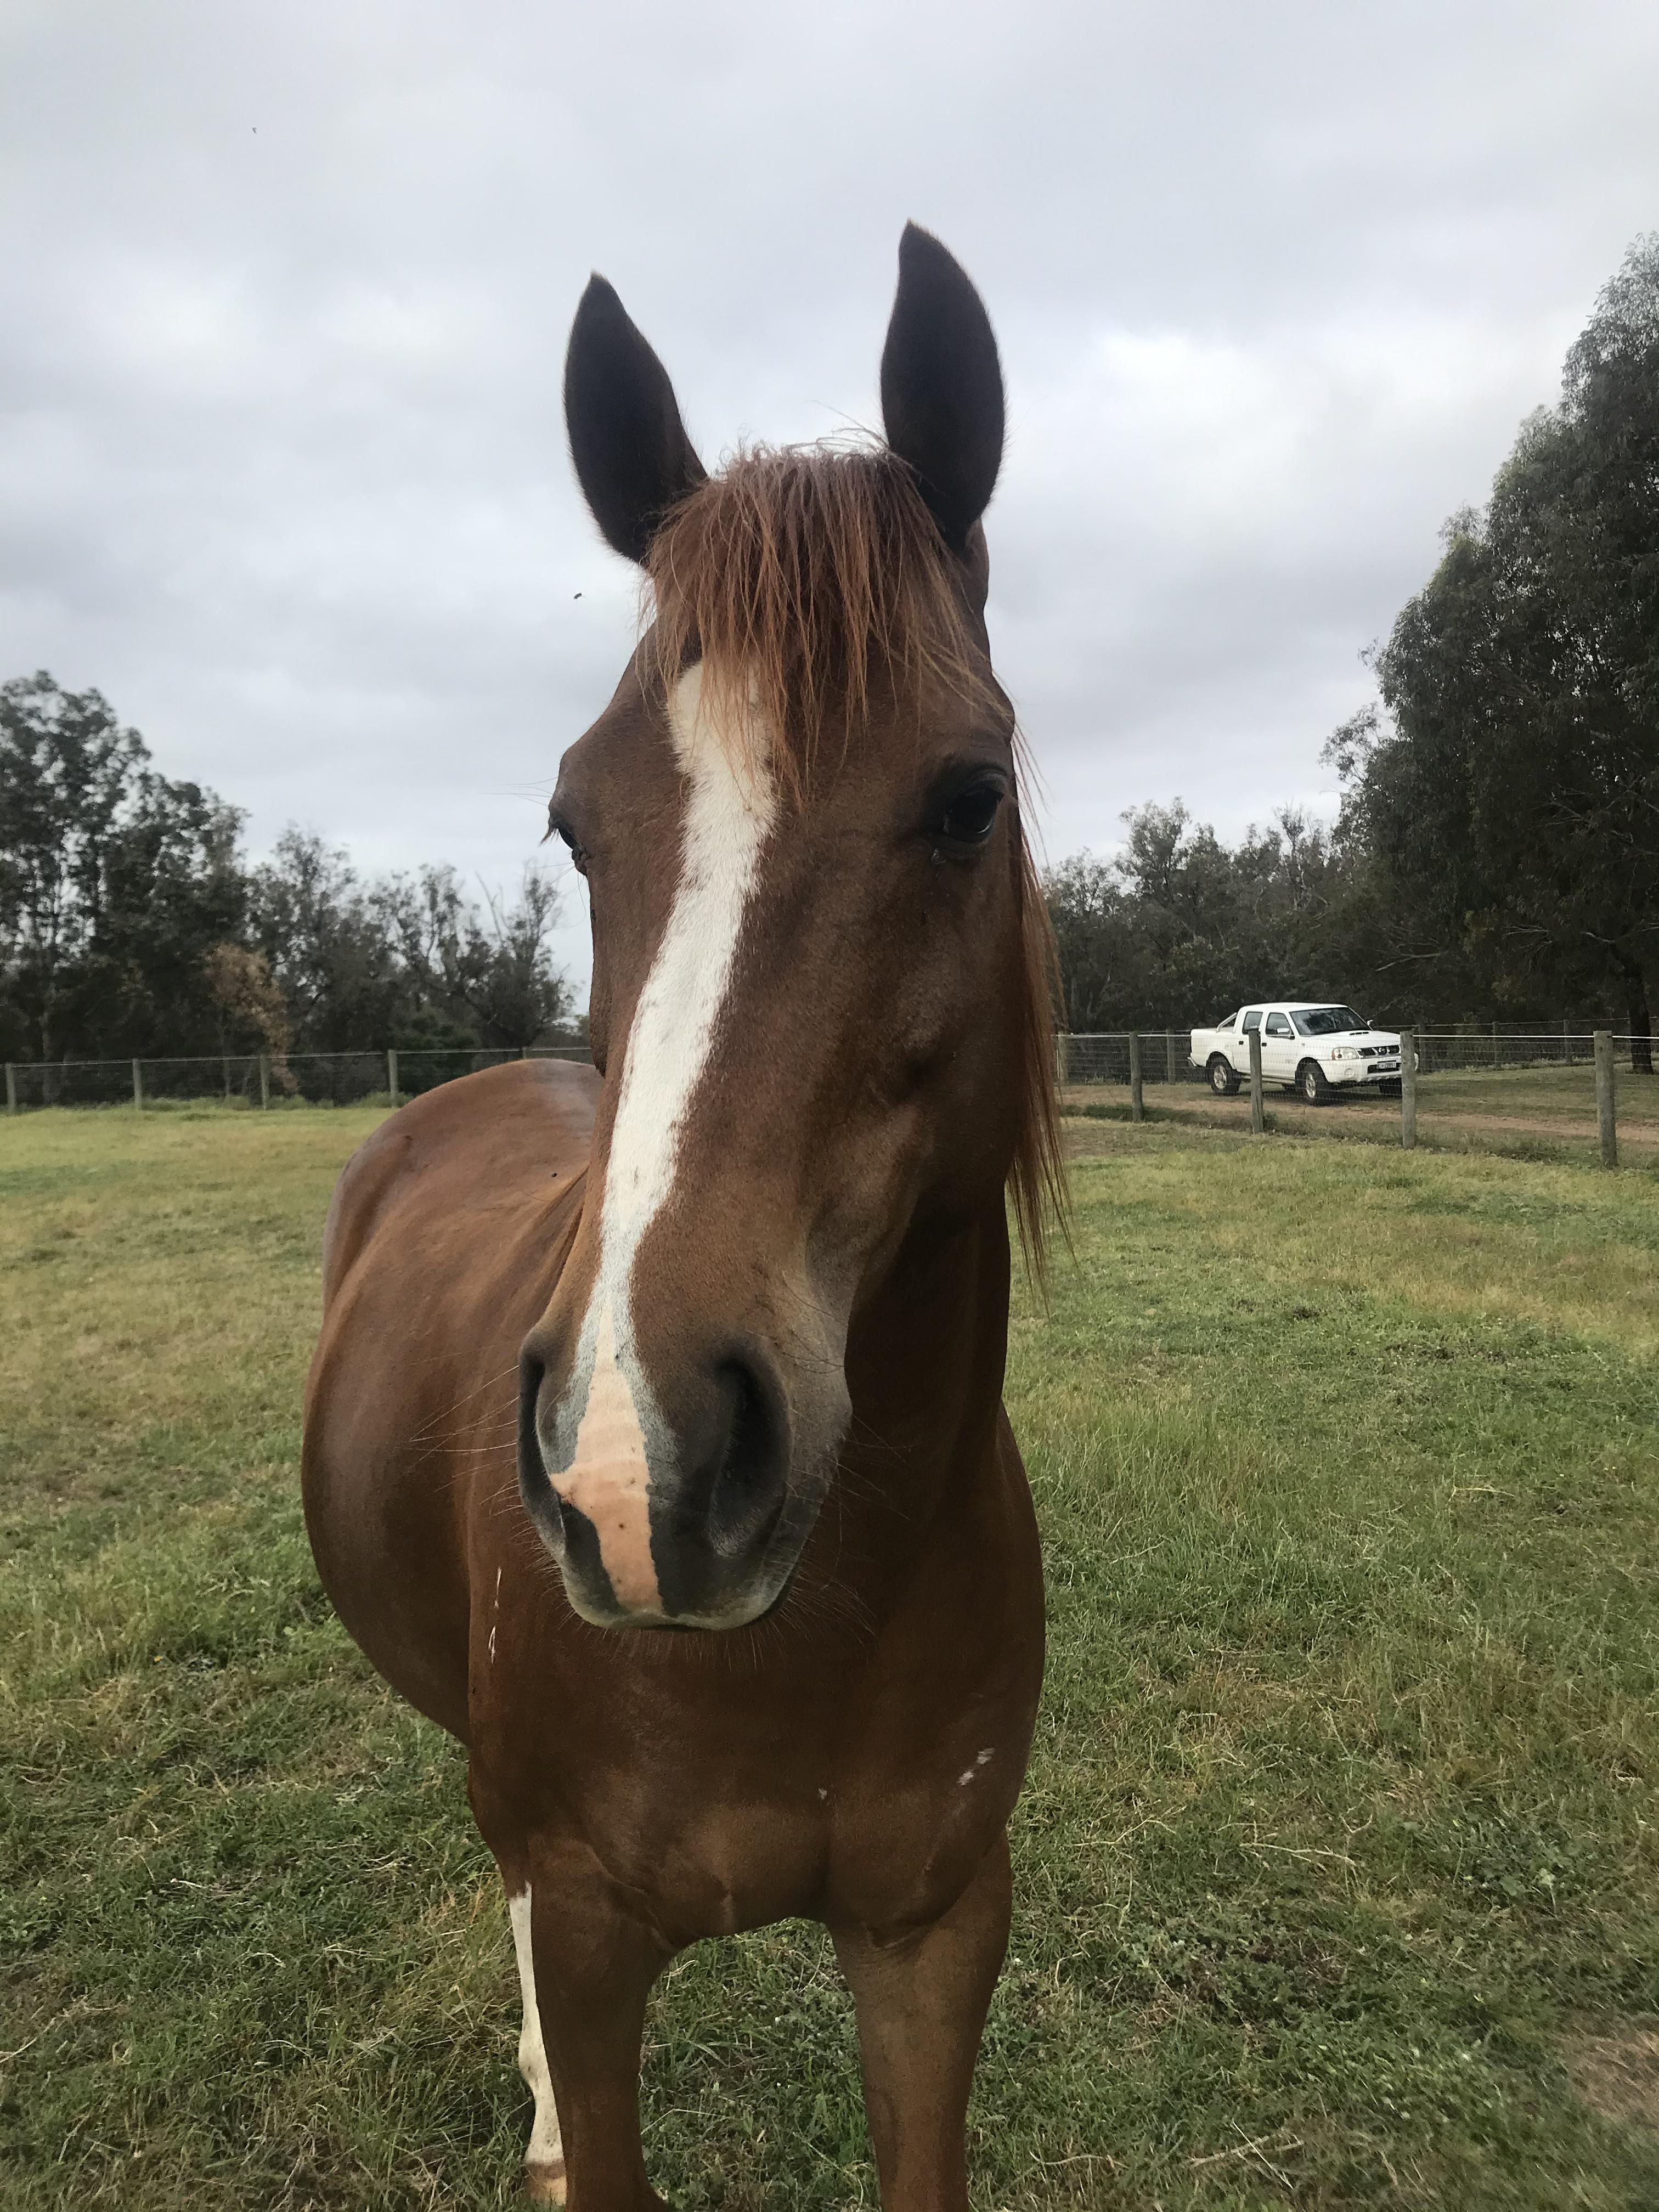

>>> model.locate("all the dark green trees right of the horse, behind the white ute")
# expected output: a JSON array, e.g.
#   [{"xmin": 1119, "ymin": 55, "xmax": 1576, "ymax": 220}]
[{"xmin": 1048, "ymin": 236, "xmax": 1659, "ymax": 1073}]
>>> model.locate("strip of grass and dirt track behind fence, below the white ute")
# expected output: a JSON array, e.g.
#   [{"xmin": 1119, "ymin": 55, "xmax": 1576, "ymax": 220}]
[{"xmin": 1066, "ymin": 1062, "xmax": 1659, "ymax": 1168}]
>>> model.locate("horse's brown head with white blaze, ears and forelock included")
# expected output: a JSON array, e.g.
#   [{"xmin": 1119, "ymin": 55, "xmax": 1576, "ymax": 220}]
[{"xmin": 520, "ymin": 228, "xmax": 1053, "ymax": 1628}]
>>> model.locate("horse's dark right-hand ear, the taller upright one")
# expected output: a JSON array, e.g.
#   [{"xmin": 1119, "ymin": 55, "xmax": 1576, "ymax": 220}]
[{"xmin": 881, "ymin": 223, "xmax": 1002, "ymax": 553}]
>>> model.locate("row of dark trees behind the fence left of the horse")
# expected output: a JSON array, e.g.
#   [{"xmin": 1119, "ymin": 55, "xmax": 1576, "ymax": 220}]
[{"xmin": 0, "ymin": 673, "xmax": 582, "ymax": 1062}]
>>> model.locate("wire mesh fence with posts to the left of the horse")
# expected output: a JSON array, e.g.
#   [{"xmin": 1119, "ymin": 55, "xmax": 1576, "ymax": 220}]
[{"xmin": 7, "ymin": 1044, "xmax": 593, "ymax": 1113}]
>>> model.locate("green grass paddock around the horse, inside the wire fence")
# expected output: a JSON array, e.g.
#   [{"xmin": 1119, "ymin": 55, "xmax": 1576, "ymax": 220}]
[{"xmin": 0, "ymin": 1110, "xmax": 1659, "ymax": 2212}]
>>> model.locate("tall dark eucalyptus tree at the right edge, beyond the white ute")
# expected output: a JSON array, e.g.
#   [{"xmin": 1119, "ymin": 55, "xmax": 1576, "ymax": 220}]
[{"xmin": 1331, "ymin": 236, "xmax": 1659, "ymax": 1070}]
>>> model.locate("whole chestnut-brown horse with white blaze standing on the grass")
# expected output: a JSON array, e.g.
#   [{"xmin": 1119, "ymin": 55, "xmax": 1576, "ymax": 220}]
[{"xmin": 305, "ymin": 228, "xmax": 1055, "ymax": 2212}]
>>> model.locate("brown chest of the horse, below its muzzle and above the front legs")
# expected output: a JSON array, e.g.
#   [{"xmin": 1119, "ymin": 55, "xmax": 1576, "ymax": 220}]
[{"xmin": 473, "ymin": 1531, "xmax": 1042, "ymax": 1944}]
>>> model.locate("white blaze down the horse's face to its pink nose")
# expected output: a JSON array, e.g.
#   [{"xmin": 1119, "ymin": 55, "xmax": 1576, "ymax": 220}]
[{"xmin": 549, "ymin": 668, "xmax": 776, "ymax": 1612}]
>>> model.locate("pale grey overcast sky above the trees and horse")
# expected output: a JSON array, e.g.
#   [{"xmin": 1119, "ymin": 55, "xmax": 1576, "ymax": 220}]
[{"xmin": 0, "ymin": 0, "xmax": 1659, "ymax": 975}]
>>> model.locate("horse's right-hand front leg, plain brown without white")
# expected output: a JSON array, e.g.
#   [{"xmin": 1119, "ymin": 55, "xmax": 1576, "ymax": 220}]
[{"xmin": 832, "ymin": 1836, "xmax": 1011, "ymax": 2212}]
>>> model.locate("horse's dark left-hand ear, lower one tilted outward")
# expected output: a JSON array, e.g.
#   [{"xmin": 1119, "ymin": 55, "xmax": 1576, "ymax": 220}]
[{"xmin": 564, "ymin": 276, "xmax": 706, "ymax": 564}]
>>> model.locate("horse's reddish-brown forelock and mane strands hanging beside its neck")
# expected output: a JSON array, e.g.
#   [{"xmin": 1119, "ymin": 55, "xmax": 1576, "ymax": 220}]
[{"xmin": 648, "ymin": 442, "xmax": 1064, "ymax": 1278}]
